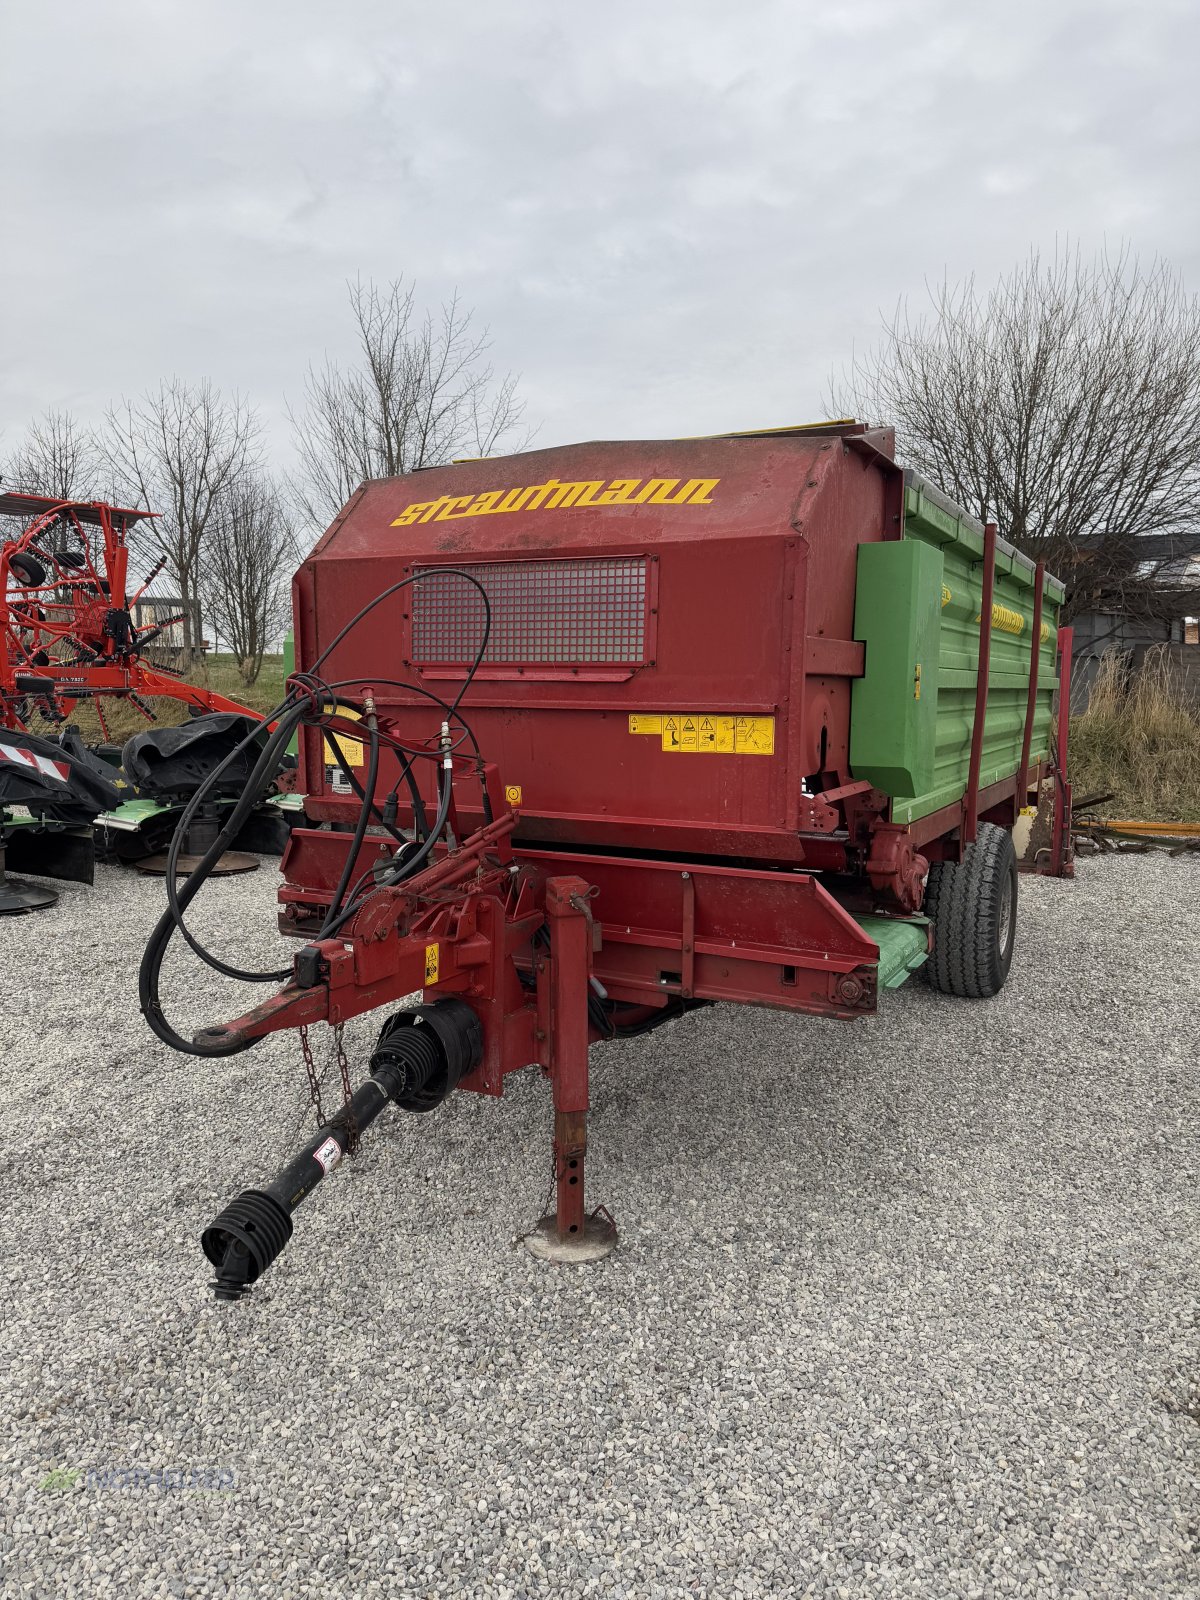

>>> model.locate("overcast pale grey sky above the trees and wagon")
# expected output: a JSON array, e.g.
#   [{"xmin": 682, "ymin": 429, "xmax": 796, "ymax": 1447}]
[{"xmin": 0, "ymin": 0, "xmax": 1200, "ymax": 458}]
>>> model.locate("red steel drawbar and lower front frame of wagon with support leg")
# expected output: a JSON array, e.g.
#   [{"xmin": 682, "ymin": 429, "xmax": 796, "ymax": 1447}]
[{"xmin": 197, "ymin": 742, "xmax": 878, "ymax": 1240}]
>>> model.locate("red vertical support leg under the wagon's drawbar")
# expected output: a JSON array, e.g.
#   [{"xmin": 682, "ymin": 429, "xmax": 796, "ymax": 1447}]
[{"xmin": 546, "ymin": 878, "xmax": 592, "ymax": 1240}]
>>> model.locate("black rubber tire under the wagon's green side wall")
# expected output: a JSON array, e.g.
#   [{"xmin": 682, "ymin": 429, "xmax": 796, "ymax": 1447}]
[{"xmin": 923, "ymin": 822, "xmax": 1018, "ymax": 1000}]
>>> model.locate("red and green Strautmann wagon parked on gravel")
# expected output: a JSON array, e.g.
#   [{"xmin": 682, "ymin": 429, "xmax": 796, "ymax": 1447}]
[{"xmin": 141, "ymin": 424, "xmax": 1069, "ymax": 1298}]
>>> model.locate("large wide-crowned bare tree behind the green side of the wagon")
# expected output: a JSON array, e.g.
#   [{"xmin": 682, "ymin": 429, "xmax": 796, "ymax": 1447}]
[{"xmin": 830, "ymin": 251, "xmax": 1200, "ymax": 616}]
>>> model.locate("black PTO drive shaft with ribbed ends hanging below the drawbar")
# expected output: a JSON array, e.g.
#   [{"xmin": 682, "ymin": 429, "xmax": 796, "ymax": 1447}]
[{"xmin": 200, "ymin": 1000, "xmax": 483, "ymax": 1301}]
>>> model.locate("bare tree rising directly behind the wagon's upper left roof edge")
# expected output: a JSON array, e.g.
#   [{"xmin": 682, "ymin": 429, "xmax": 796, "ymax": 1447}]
[{"xmin": 288, "ymin": 280, "xmax": 525, "ymax": 528}]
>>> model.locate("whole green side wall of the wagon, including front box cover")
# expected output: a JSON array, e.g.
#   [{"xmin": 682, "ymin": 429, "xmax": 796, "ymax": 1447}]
[{"xmin": 850, "ymin": 486, "xmax": 1064, "ymax": 822}]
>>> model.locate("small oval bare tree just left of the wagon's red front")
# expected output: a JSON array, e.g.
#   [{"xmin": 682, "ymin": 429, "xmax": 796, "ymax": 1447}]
[{"xmin": 200, "ymin": 472, "xmax": 296, "ymax": 683}]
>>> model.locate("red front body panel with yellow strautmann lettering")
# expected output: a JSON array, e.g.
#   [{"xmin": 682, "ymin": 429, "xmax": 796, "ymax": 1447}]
[{"xmin": 296, "ymin": 435, "xmax": 894, "ymax": 862}]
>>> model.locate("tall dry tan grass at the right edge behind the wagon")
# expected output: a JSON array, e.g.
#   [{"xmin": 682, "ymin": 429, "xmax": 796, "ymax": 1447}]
[{"xmin": 1070, "ymin": 650, "xmax": 1200, "ymax": 822}]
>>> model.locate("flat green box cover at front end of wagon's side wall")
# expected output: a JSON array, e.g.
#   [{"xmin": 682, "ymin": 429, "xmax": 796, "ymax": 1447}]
[{"xmin": 850, "ymin": 539, "xmax": 942, "ymax": 798}]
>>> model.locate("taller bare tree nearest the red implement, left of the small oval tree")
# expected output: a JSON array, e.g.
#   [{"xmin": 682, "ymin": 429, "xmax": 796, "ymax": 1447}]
[{"xmin": 104, "ymin": 378, "xmax": 259, "ymax": 659}]
